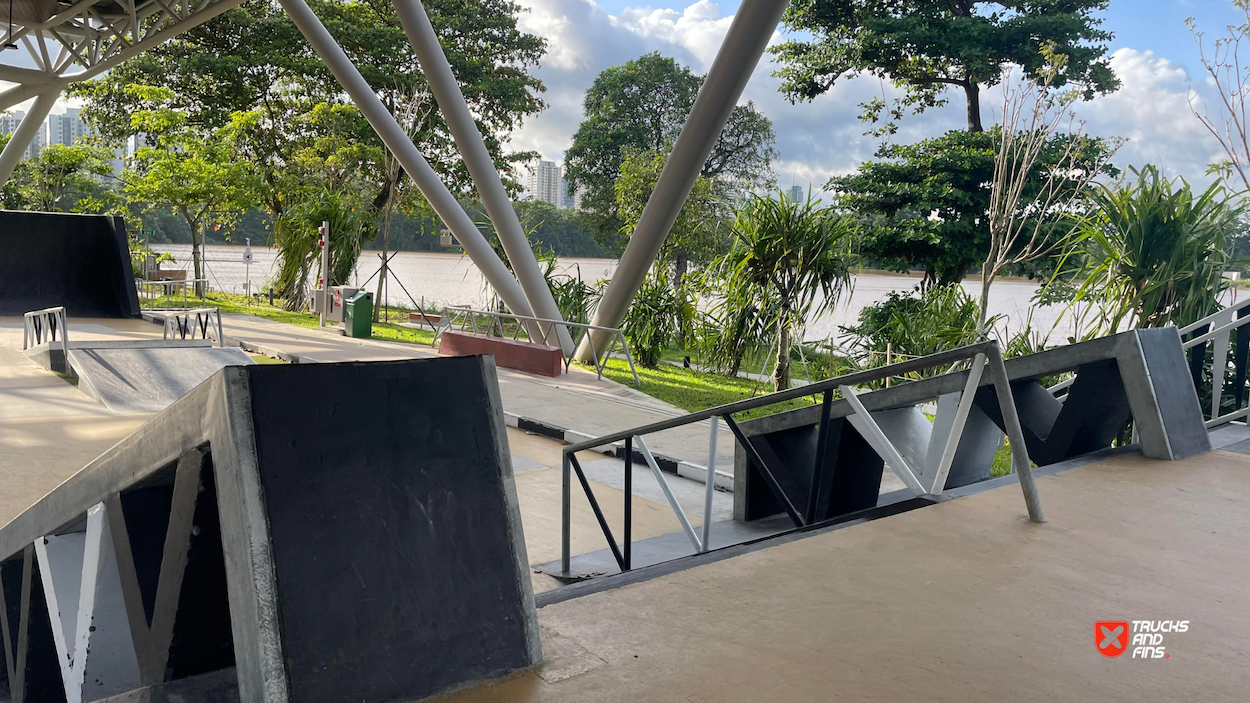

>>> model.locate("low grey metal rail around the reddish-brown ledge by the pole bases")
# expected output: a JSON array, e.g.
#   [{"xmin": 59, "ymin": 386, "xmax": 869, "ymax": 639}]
[{"xmin": 432, "ymin": 305, "xmax": 643, "ymax": 388}]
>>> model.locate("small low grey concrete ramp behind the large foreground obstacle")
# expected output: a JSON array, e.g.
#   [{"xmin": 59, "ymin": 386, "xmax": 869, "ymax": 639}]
[{"xmin": 70, "ymin": 346, "xmax": 256, "ymax": 414}]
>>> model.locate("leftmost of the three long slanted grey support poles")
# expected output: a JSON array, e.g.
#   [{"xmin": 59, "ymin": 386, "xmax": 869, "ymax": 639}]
[{"xmin": 279, "ymin": 0, "xmax": 543, "ymax": 327}]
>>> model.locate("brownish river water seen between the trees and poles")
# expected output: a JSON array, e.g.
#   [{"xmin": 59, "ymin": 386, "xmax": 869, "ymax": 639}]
[{"xmin": 153, "ymin": 244, "xmax": 1090, "ymax": 343}]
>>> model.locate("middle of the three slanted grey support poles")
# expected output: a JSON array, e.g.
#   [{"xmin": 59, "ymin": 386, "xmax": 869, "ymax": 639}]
[{"xmin": 395, "ymin": 0, "xmax": 573, "ymax": 354}]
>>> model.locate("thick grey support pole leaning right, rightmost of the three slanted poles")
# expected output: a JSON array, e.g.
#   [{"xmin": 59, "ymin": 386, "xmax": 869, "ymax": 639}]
[{"xmin": 578, "ymin": 0, "xmax": 790, "ymax": 362}]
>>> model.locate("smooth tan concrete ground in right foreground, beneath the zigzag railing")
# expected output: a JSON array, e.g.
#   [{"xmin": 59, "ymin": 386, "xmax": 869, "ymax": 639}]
[{"xmin": 440, "ymin": 452, "xmax": 1250, "ymax": 703}]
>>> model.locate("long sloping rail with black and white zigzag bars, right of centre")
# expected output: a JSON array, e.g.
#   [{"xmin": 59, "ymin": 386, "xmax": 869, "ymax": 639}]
[{"xmin": 560, "ymin": 340, "xmax": 1044, "ymax": 574}]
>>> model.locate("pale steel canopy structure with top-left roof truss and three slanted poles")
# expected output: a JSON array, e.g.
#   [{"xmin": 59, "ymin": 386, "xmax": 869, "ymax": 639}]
[{"xmin": 0, "ymin": 0, "xmax": 789, "ymax": 360}]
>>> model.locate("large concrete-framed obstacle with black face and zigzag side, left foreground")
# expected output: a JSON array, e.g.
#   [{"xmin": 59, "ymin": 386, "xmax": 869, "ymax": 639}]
[{"xmin": 0, "ymin": 357, "xmax": 541, "ymax": 703}]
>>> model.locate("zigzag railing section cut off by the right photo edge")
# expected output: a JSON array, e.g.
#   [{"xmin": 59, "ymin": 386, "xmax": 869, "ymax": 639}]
[{"xmin": 1178, "ymin": 298, "xmax": 1250, "ymax": 428}]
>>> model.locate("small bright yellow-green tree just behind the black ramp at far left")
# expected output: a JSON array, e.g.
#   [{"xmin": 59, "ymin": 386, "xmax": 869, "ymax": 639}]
[{"xmin": 123, "ymin": 89, "xmax": 248, "ymax": 295}]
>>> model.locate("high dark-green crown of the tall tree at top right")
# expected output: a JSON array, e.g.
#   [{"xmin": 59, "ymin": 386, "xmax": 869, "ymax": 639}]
[{"xmin": 773, "ymin": 0, "xmax": 1119, "ymax": 133}]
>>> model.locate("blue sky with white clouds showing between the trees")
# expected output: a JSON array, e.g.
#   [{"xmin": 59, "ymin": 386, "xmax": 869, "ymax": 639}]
[{"xmin": 511, "ymin": 0, "xmax": 1244, "ymax": 190}]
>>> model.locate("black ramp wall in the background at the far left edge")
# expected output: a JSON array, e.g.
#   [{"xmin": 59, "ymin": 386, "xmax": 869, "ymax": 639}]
[{"xmin": 0, "ymin": 210, "xmax": 139, "ymax": 318}]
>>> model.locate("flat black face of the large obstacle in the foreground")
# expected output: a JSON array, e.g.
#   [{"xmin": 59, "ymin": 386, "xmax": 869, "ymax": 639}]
[{"xmin": 248, "ymin": 357, "xmax": 539, "ymax": 703}]
